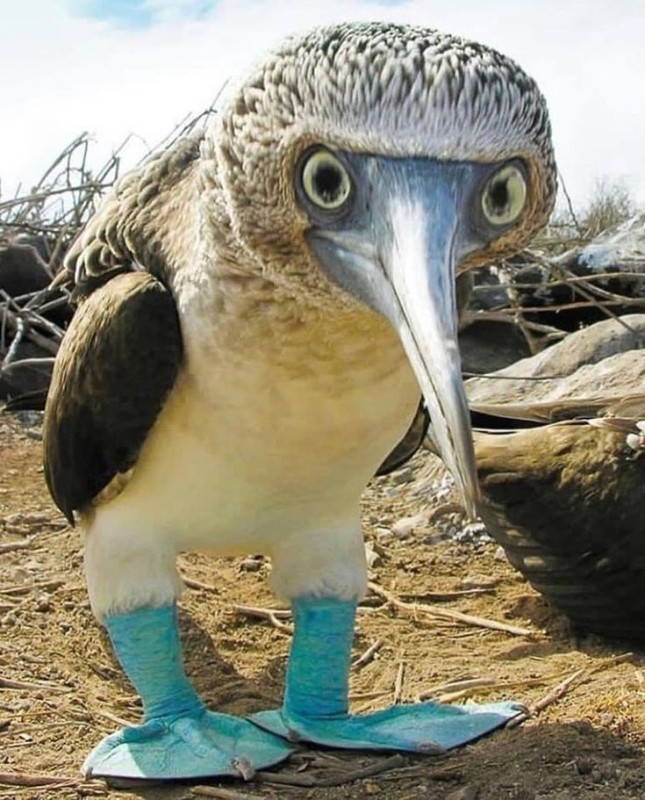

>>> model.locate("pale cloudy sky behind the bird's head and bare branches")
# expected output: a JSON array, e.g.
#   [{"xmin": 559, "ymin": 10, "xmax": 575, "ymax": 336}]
[{"xmin": 0, "ymin": 0, "xmax": 645, "ymax": 208}]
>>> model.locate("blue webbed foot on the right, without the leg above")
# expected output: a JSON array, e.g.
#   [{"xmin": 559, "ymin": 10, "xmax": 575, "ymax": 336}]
[{"xmin": 250, "ymin": 703, "xmax": 523, "ymax": 753}]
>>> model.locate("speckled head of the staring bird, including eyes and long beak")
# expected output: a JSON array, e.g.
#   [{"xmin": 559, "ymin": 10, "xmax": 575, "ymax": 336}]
[{"xmin": 204, "ymin": 23, "xmax": 556, "ymax": 512}]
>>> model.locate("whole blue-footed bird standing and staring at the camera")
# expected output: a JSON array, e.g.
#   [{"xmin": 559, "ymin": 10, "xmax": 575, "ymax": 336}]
[{"xmin": 43, "ymin": 22, "xmax": 556, "ymax": 779}]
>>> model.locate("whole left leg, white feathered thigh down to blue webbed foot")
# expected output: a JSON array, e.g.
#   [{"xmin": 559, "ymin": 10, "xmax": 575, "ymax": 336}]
[{"xmin": 83, "ymin": 512, "xmax": 293, "ymax": 779}]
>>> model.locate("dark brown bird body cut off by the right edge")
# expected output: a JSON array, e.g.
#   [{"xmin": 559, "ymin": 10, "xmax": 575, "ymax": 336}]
[{"xmin": 475, "ymin": 404, "xmax": 645, "ymax": 642}]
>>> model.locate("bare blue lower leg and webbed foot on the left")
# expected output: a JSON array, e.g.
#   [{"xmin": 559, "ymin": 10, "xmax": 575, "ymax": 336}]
[{"xmin": 83, "ymin": 605, "xmax": 293, "ymax": 779}]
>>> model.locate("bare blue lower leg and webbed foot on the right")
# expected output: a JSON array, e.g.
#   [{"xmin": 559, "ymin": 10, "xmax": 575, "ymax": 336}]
[{"xmin": 250, "ymin": 598, "xmax": 522, "ymax": 752}]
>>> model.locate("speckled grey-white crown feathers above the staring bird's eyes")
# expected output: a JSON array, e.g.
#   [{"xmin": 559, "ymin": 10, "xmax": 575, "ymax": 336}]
[{"xmin": 213, "ymin": 23, "xmax": 556, "ymax": 260}]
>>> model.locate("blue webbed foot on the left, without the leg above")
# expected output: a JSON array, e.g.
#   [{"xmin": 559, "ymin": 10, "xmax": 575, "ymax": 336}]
[{"xmin": 83, "ymin": 709, "xmax": 293, "ymax": 780}]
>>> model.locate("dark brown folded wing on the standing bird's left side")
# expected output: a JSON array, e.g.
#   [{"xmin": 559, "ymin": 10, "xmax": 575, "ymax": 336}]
[{"xmin": 43, "ymin": 272, "xmax": 182, "ymax": 523}]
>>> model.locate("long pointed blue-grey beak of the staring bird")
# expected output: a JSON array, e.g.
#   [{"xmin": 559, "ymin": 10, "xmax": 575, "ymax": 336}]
[{"xmin": 311, "ymin": 158, "xmax": 479, "ymax": 517}]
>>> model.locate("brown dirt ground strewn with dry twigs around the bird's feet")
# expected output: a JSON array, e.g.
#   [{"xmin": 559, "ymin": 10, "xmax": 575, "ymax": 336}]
[{"xmin": 0, "ymin": 416, "xmax": 645, "ymax": 800}]
